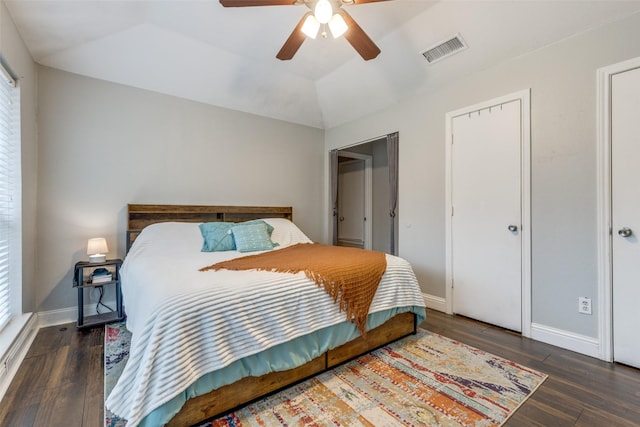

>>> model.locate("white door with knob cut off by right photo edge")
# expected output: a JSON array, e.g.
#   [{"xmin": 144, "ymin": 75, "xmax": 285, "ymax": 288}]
[{"xmin": 611, "ymin": 68, "xmax": 640, "ymax": 368}]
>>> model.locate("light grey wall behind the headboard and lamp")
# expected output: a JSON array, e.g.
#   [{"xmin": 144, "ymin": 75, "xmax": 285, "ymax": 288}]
[{"xmin": 36, "ymin": 67, "xmax": 323, "ymax": 311}]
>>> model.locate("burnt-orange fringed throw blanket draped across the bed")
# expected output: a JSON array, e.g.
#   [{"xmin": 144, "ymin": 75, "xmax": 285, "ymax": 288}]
[{"xmin": 200, "ymin": 243, "xmax": 387, "ymax": 336}]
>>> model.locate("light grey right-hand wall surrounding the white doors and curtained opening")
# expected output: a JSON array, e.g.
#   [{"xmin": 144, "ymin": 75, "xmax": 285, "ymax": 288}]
[{"xmin": 325, "ymin": 16, "xmax": 640, "ymax": 337}]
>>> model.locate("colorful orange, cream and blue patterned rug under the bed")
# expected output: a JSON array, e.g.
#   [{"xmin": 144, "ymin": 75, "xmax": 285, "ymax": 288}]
[{"xmin": 105, "ymin": 324, "xmax": 547, "ymax": 427}]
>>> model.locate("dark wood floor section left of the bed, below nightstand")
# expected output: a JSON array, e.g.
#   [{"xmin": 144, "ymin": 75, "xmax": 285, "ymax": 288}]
[{"xmin": 0, "ymin": 323, "xmax": 104, "ymax": 427}]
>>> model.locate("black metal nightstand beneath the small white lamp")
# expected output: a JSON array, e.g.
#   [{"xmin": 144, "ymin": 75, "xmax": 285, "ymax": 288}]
[{"xmin": 73, "ymin": 259, "xmax": 125, "ymax": 329}]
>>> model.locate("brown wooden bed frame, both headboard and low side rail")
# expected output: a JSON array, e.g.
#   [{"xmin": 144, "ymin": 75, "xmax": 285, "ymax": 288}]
[{"xmin": 127, "ymin": 204, "xmax": 417, "ymax": 427}]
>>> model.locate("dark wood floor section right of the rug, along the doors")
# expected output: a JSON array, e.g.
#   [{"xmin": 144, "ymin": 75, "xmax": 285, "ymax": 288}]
[{"xmin": 420, "ymin": 311, "xmax": 640, "ymax": 427}]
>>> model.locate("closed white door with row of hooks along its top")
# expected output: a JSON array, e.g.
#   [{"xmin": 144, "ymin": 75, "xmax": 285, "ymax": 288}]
[{"xmin": 448, "ymin": 92, "xmax": 528, "ymax": 332}]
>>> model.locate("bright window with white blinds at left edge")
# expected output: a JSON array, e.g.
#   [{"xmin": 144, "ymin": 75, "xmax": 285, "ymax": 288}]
[{"xmin": 0, "ymin": 64, "xmax": 22, "ymax": 330}]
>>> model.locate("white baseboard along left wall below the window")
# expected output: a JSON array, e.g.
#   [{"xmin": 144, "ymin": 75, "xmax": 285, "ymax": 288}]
[{"xmin": 0, "ymin": 313, "xmax": 38, "ymax": 400}]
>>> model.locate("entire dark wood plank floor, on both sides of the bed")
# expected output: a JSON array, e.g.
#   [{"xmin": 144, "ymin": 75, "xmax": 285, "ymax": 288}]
[{"xmin": 0, "ymin": 311, "xmax": 640, "ymax": 427}]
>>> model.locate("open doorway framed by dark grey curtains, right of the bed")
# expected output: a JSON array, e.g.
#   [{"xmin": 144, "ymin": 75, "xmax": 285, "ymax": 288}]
[{"xmin": 329, "ymin": 133, "xmax": 398, "ymax": 255}]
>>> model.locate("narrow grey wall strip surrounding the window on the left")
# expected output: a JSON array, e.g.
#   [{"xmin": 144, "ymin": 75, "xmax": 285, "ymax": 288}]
[{"xmin": 0, "ymin": 2, "xmax": 38, "ymax": 313}]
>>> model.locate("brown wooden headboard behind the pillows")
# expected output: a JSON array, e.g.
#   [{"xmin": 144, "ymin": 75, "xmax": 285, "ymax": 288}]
[{"xmin": 127, "ymin": 204, "xmax": 293, "ymax": 252}]
